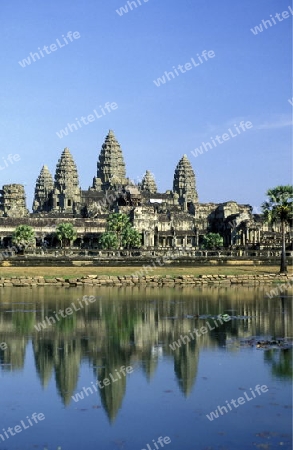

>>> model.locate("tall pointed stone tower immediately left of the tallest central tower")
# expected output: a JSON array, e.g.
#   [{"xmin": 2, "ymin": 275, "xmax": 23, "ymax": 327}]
[{"xmin": 52, "ymin": 148, "xmax": 81, "ymax": 214}]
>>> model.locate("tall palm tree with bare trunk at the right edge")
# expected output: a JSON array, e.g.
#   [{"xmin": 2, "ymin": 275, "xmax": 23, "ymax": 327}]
[{"xmin": 262, "ymin": 185, "xmax": 293, "ymax": 273}]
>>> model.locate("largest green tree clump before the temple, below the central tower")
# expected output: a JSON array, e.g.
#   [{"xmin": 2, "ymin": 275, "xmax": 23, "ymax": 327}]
[{"xmin": 99, "ymin": 213, "xmax": 141, "ymax": 249}]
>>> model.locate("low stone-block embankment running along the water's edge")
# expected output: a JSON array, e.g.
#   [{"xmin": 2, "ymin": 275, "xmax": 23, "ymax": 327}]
[{"xmin": 0, "ymin": 273, "xmax": 293, "ymax": 287}]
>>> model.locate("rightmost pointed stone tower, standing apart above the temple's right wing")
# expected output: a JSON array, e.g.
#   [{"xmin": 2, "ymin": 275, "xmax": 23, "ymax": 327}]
[{"xmin": 173, "ymin": 155, "xmax": 198, "ymax": 210}]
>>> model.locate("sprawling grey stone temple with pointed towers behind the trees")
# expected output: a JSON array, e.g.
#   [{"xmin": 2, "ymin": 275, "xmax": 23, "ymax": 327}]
[{"xmin": 0, "ymin": 131, "xmax": 289, "ymax": 249}]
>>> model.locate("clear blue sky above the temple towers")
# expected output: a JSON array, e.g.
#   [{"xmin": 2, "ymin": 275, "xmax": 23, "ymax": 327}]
[{"xmin": 0, "ymin": 0, "xmax": 293, "ymax": 209}]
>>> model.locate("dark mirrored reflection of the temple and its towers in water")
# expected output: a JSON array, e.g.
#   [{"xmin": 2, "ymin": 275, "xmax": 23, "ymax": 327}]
[{"xmin": 0, "ymin": 286, "xmax": 293, "ymax": 422}]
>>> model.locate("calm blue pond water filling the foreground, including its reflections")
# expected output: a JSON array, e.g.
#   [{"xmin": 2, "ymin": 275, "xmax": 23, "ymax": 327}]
[{"xmin": 0, "ymin": 286, "xmax": 293, "ymax": 450}]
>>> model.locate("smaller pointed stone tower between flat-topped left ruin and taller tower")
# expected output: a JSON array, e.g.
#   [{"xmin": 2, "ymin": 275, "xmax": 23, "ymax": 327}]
[{"xmin": 33, "ymin": 166, "xmax": 54, "ymax": 213}]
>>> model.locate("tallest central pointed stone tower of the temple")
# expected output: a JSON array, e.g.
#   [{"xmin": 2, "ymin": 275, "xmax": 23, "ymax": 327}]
[{"xmin": 93, "ymin": 130, "xmax": 127, "ymax": 192}]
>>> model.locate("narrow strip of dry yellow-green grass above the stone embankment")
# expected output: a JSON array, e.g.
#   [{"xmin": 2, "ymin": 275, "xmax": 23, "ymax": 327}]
[{"xmin": 0, "ymin": 266, "xmax": 292, "ymax": 278}]
